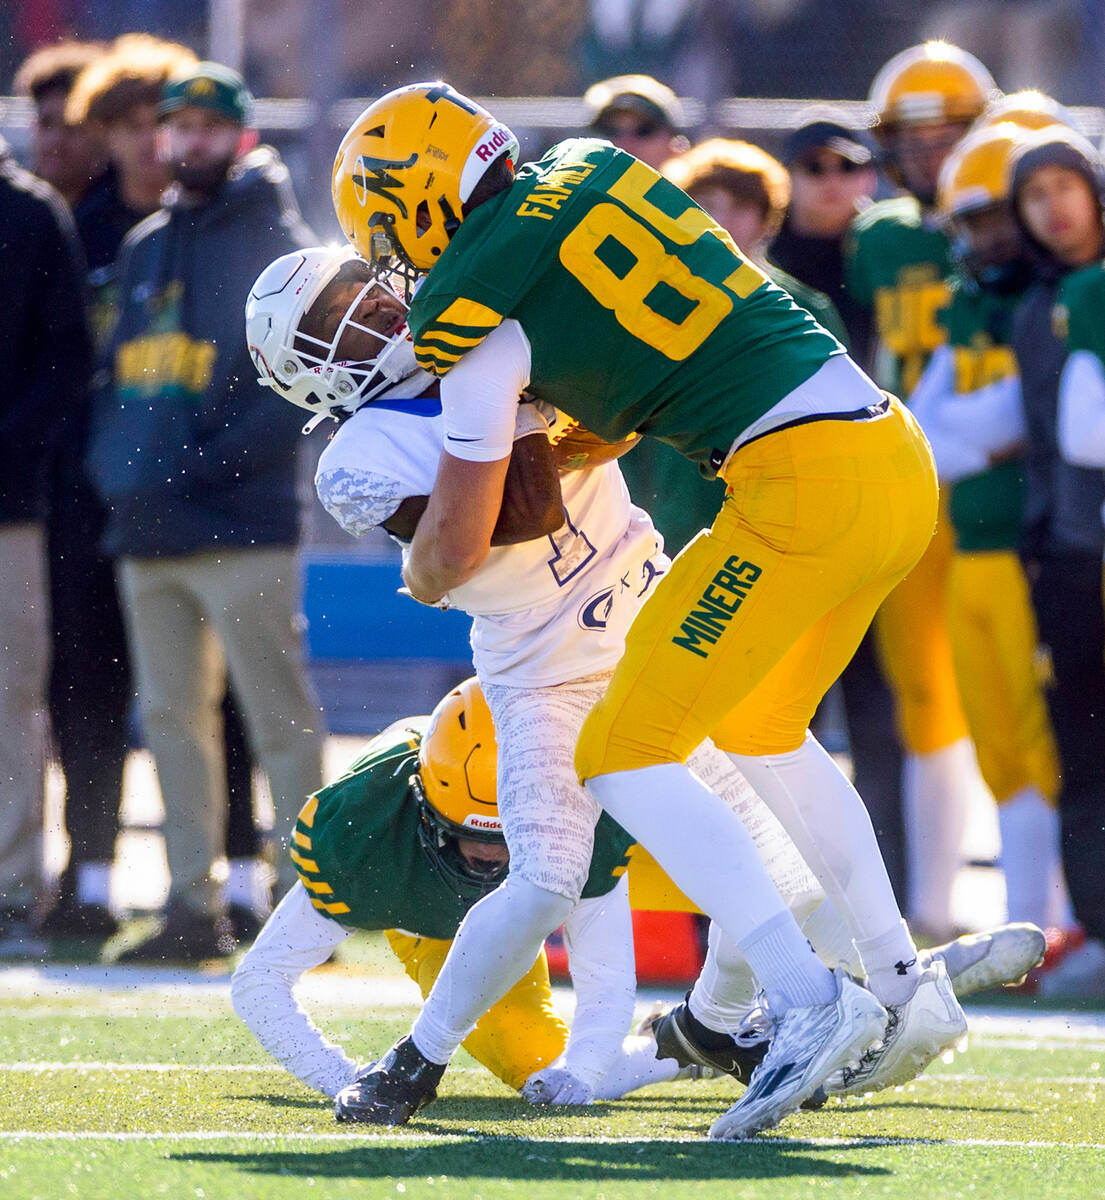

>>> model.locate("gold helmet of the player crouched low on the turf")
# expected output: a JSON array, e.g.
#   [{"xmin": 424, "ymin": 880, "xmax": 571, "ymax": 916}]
[{"xmin": 410, "ymin": 678, "xmax": 508, "ymax": 895}]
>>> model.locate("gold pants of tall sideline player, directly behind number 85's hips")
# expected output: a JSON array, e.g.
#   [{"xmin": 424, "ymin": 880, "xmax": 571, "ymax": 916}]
[{"xmin": 875, "ymin": 506, "xmax": 967, "ymax": 755}]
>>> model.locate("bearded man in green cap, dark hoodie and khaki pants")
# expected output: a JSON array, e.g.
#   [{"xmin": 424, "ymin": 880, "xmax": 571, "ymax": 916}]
[{"xmin": 89, "ymin": 62, "xmax": 322, "ymax": 960}]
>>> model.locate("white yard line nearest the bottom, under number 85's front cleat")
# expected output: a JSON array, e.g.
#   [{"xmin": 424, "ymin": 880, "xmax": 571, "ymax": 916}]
[{"xmin": 0, "ymin": 1129, "xmax": 1105, "ymax": 1151}]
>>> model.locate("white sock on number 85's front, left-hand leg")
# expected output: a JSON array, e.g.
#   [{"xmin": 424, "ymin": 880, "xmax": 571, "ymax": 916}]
[{"xmin": 587, "ymin": 763, "xmax": 836, "ymax": 1003}]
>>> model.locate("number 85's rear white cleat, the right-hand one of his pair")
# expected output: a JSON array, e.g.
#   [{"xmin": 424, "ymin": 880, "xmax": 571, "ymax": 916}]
[{"xmin": 825, "ymin": 959, "xmax": 967, "ymax": 1096}]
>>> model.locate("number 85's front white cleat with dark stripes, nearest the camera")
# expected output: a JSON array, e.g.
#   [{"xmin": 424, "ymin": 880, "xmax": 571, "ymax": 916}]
[{"xmin": 710, "ymin": 968, "xmax": 887, "ymax": 1141}]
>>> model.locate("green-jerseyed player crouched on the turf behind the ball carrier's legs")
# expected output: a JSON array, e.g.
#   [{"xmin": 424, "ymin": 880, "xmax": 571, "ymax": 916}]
[{"xmin": 232, "ymin": 679, "xmax": 686, "ymax": 1104}]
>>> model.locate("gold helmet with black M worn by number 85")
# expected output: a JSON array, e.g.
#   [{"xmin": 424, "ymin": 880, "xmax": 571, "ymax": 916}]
[{"xmin": 331, "ymin": 83, "xmax": 518, "ymax": 271}]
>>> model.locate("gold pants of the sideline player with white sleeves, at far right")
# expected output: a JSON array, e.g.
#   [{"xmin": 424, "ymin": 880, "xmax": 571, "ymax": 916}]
[{"xmin": 948, "ymin": 550, "xmax": 1058, "ymax": 804}]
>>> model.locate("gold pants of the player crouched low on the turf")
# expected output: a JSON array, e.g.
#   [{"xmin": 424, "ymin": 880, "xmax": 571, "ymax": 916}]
[{"xmin": 386, "ymin": 929, "xmax": 567, "ymax": 1090}]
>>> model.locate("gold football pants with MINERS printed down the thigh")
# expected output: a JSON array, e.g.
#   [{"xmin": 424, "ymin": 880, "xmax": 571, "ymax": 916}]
[{"xmin": 576, "ymin": 400, "xmax": 937, "ymax": 779}]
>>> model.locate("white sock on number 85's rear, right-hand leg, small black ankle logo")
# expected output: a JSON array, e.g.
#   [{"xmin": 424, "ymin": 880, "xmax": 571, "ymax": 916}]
[{"xmin": 731, "ymin": 733, "xmax": 918, "ymax": 1003}]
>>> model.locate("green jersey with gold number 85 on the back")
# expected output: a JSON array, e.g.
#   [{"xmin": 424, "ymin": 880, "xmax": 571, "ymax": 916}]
[{"xmin": 410, "ymin": 139, "xmax": 843, "ymax": 474}]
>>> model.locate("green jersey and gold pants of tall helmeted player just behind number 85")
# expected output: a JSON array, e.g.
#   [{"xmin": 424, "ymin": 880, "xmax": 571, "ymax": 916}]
[{"xmin": 845, "ymin": 196, "xmax": 967, "ymax": 755}]
